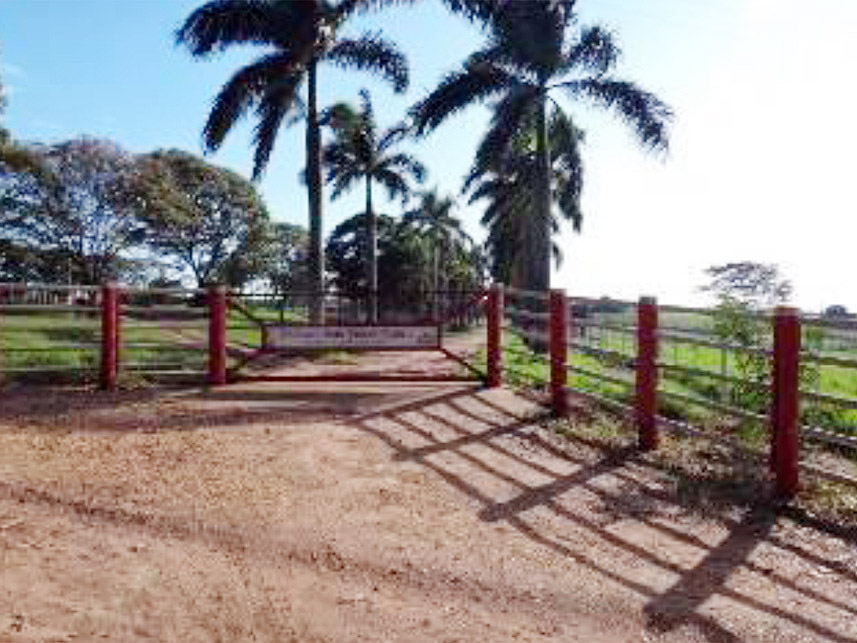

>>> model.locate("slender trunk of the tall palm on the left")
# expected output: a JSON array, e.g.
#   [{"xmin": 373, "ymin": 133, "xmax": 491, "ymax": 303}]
[{"xmin": 306, "ymin": 61, "xmax": 324, "ymax": 324}]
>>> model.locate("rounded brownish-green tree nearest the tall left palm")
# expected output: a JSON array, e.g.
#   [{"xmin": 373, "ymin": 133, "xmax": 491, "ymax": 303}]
[{"xmin": 135, "ymin": 150, "xmax": 268, "ymax": 287}]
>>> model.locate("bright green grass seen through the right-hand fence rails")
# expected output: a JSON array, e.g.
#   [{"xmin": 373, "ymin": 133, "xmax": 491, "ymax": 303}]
[{"xmin": 492, "ymin": 306, "xmax": 857, "ymax": 448}]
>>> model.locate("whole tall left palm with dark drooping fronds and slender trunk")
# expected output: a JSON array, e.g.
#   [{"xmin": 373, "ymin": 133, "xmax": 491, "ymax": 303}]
[{"xmin": 176, "ymin": 0, "xmax": 410, "ymax": 322}]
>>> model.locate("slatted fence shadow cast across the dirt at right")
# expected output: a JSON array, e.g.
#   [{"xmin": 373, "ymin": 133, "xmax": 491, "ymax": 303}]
[{"xmin": 350, "ymin": 392, "xmax": 857, "ymax": 643}]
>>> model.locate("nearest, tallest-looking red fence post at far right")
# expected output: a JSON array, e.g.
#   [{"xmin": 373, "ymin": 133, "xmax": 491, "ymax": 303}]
[{"xmin": 771, "ymin": 306, "xmax": 800, "ymax": 498}]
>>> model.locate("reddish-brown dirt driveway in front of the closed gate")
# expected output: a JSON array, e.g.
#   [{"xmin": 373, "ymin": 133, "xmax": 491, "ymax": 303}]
[{"xmin": 0, "ymin": 354, "xmax": 857, "ymax": 643}]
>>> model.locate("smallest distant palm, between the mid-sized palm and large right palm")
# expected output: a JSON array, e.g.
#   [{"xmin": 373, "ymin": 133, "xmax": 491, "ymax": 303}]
[{"xmin": 402, "ymin": 189, "xmax": 473, "ymax": 320}]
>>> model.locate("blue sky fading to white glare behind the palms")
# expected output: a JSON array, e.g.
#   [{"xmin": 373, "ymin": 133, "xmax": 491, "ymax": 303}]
[{"xmin": 0, "ymin": 0, "xmax": 857, "ymax": 310}]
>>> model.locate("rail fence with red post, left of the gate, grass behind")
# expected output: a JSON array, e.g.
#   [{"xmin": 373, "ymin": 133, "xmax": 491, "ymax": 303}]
[{"xmin": 0, "ymin": 284, "xmax": 209, "ymax": 387}]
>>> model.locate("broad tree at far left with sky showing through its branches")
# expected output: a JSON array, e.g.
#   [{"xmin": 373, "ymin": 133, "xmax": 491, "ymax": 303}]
[{"xmin": 0, "ymin": 139, "xmax": 138, "ymax": 284}]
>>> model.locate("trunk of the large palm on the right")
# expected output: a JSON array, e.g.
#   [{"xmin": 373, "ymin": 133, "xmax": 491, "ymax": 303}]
[{"xmin": 526, "ymin": 91, "xmax": 551, "ymax": 291}]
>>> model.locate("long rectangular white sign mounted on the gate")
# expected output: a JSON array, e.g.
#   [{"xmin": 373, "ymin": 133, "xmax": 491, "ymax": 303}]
[{"xmin": 265, "ymin": 325, "xmax": 440, "ymax": 349}]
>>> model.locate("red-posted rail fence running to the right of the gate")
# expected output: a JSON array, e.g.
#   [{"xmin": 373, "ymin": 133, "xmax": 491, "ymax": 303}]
[{"xmin": 488, "ymin": 287, "xmax": 857, "ymax": 495}]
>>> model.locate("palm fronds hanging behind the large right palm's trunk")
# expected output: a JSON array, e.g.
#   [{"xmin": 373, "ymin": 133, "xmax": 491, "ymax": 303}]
[{"xmin": 463, "ymin": 111, "xmax": 584, "ymax": 287}]
